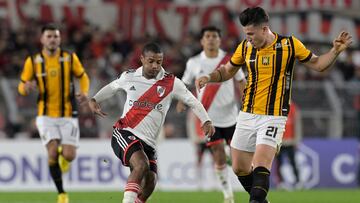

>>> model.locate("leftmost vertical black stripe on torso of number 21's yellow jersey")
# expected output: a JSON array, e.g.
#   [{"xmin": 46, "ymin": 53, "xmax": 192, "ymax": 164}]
[{"xmin": 246, "ymin": 47, "xmax": 257, "ymax": 113}]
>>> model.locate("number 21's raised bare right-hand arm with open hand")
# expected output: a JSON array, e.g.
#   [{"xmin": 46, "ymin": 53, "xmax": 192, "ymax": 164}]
[{"xmin": 304, "ymin": 31, "xmax": 352, "ymax": 72}]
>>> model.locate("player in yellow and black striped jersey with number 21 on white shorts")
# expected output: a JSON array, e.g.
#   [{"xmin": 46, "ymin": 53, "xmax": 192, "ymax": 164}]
[{"xmin": 196, "ymin": 7, "xmax": 352, "ymax": 203}]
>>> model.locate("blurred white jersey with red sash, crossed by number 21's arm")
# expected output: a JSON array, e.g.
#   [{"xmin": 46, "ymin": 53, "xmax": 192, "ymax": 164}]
[{"xmin": 182, "ymin": 50, "xmax": 245, "ymax": 127}]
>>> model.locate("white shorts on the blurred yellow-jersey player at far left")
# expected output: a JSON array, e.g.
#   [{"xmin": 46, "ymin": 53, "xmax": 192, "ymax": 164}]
[{"xmin": 36, "ymin": 116, "xmax": 80, "ymax": 147}]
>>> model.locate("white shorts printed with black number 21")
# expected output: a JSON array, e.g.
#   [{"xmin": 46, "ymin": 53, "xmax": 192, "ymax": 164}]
[{"xmin": 230, "ymin": 111, "xmax": 287, "ymax": 152}]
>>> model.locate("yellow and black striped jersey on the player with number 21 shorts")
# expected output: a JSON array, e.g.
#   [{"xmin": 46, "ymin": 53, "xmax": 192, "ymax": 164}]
[{"xmin": 230, "ymin": 33, "xmax": 312, "ymax": 116}]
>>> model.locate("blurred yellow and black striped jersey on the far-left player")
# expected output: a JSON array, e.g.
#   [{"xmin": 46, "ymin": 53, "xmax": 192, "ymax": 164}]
[{"xmin": 18, "ymin": 49, "xmax": 89, "ymax": 117}]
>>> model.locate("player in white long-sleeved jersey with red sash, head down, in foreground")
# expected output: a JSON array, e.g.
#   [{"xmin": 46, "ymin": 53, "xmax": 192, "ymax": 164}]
[{"xmin": 89, "ymin": 43, "xmax": 215, "ymax": 203}]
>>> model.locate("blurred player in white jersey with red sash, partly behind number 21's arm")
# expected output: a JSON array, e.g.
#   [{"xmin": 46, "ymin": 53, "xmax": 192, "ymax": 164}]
[{"xmin": 177, "ymin": 26, "xmax": 246, "ymax": 203}]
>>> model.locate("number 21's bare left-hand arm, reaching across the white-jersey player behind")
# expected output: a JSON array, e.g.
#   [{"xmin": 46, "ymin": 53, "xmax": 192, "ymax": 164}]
[{"xmin": 195, "ymin": 62, "xmax": 240, "ymax": 90}]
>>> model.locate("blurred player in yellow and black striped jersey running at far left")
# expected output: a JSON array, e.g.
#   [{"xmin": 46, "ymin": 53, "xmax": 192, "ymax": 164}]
[{"xmin": 18, "ymin": 24, "xmax": 89, "ymax": 203}]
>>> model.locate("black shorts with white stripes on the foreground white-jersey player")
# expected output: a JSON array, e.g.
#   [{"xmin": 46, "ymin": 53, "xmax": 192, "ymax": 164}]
[{"xmin": 111, "ymin": 128, "xmax": 157, "ymax": 173}]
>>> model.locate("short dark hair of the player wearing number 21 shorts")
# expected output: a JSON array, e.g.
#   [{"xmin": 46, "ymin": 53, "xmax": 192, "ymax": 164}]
[{"xmin": 239, "ymin": 7, "xmax": 269, "ymax": 26}]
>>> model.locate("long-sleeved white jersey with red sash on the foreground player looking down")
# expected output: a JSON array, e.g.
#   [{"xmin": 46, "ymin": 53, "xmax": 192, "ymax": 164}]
[{"xmin": 109, "ymin": 67, "xmax": 210, "ymax": 148}]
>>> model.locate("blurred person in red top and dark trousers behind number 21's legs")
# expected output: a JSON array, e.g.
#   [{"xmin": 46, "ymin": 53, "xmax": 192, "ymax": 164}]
[{"xmin": 276, "ymin": 101, "xmax": 301, "ymax": 189}]
